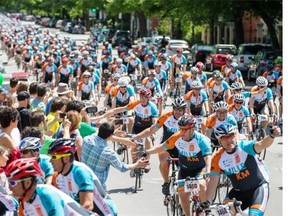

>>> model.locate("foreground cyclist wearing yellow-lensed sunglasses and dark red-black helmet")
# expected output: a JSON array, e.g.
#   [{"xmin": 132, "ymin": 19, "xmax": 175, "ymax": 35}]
[{"xmin": 48, "ymin": 138, "xmax": 117, "ymax": 215}]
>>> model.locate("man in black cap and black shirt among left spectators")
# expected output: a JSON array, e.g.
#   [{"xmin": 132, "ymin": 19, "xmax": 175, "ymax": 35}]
[{"xmin": 17, "ymin": 91, "xmax": 31, "ymax": 132}]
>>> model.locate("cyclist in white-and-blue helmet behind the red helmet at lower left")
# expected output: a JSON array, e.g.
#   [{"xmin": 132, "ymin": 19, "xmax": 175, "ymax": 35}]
[{"xmin": 19, "ymin": 137, "xmax": 54, "ymax": 184}]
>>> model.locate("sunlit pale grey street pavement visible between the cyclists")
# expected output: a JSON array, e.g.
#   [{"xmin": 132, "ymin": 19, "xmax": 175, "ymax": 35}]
[{"xmin": 0, "ymin": 21, "xmax": 283, "ymax": 216}]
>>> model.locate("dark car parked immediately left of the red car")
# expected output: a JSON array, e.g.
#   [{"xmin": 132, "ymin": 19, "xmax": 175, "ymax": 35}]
[{"xmin": 187, "ymin": 44, "xmax": 213, "ymax": 65}]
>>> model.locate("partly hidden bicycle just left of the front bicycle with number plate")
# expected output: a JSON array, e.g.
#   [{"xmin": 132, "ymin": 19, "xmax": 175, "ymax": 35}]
[{"xmin": 164, "ymin": 157, "xmax": 183, "ymax": 216}]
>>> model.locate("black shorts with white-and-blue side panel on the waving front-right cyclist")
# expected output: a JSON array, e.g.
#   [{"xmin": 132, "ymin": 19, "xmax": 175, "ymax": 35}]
[{"xmin": 224, "ymin": 182, "xmax": 269, "ymax": 216}]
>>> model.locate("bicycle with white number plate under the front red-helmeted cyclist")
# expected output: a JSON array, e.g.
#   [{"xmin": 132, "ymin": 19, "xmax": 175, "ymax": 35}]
[{"xmin": 176, "ymin": 176, "xmax": 205, "ymax": 216}]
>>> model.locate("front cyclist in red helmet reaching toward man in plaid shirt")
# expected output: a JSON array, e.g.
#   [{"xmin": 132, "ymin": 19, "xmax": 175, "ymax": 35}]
[{"xmin": 146, "ymin": 114, "xmax": 212, "ymax": 215}]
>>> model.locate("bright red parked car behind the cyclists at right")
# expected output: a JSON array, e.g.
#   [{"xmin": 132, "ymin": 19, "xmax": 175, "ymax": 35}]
[{"xmin": 205, "ymin": 44, "xmax": 237, "ymax": 71}]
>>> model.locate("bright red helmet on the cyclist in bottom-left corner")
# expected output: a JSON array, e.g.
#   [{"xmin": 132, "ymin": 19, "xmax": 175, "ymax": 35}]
[{"xmin": 5, "ymin": 158, "xmax": 43, "ymax": 179}]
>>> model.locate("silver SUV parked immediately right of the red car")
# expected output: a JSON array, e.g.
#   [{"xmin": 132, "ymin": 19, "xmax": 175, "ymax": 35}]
[{"xmin": 234, "ymin": 43, "xmax": 271, "ymax": 73}]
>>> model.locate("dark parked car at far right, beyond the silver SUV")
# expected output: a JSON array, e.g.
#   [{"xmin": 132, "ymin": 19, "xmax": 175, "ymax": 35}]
[{"xmin": 247, "ymin": 50, "xmax": 281, "ymax": 81}]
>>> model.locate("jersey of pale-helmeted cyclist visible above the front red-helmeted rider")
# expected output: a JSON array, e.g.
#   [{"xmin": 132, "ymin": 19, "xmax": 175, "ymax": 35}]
[{"xmin": 184, "ymin": 90, "xmax": 208, "ymax": 116}]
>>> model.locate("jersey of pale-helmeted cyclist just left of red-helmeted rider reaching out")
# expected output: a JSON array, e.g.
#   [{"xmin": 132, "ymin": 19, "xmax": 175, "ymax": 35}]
[{"xmin": 111, "ymin": 85, "xmax": 135, "ymax": 107}]
